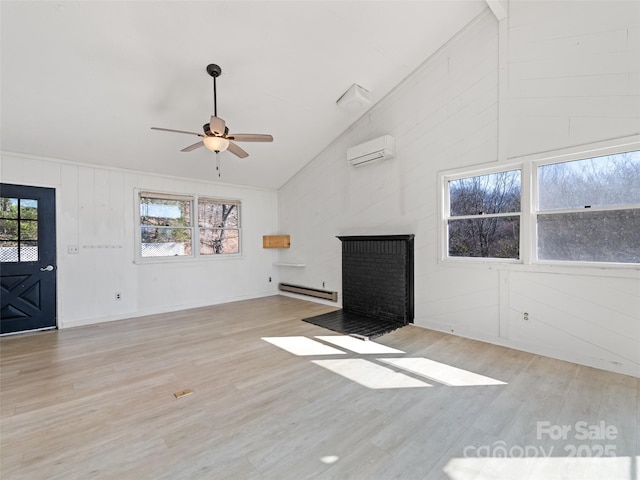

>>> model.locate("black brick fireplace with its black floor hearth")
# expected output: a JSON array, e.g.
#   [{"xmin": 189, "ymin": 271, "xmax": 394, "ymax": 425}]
[{"xmin": 303, "ymin": 234, "xmax": 414, "ymax": 339}]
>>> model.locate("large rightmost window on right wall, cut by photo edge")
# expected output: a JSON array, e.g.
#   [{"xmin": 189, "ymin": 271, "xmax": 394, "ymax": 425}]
[{"xmin": 537, "ymin": 151, "xmax": 640, "ymax": 263}]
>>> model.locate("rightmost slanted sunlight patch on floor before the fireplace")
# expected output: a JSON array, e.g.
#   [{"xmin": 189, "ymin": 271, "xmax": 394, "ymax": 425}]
[{"xmin": 377, "ymin": 357, "xmax": 506, "ymax": 387}]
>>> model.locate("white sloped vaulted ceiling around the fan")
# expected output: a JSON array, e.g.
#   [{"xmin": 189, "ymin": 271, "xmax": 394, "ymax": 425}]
[{"xmin": 0, "ymin": 0, "xmax": 487, "ymax": 188}]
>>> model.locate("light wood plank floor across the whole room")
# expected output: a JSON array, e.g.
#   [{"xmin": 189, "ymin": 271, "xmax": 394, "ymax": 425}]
[{"xmin": 0, "ymin": 296, "xmax": 640, "ymax": 480}]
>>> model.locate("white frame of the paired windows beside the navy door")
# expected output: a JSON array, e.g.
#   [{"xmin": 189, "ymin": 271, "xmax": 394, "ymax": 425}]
[{"xmin": 134, "ymin": 188, "xmax": 243, "ymax": 264}]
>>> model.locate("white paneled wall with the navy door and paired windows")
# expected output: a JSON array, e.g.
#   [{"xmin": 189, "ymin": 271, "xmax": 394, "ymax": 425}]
[{"xmin": 0, "ymin": 153, "xmax": 278, "ymax": 328}]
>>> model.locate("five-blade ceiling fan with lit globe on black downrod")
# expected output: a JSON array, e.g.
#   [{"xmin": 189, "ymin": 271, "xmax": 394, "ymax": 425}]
[{"xmin": 151, "ymin": 63, "xmax": 273, "ymax": 158}]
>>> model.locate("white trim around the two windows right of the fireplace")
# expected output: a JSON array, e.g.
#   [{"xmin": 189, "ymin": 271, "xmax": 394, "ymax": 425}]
[{"xmin": 438, "ymin": 135, "xmax": 640, "ymax": 277}]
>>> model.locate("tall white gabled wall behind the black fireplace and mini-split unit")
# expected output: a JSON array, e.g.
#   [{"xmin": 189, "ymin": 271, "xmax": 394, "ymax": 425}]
[{"xmin": 278, "ymin": 1, "xmax": 640, "ymax": 376}]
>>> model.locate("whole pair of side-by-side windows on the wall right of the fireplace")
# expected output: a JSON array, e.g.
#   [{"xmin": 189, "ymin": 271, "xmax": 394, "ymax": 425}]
[{"xmin": 440, "ymin": 141, "xmax": 640, "ymax": 268}]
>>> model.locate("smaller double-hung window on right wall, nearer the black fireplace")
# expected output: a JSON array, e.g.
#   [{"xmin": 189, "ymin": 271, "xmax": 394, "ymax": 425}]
[{"xmin": 447, "ymin": 170, "xmax": 521, "ymax": 259}]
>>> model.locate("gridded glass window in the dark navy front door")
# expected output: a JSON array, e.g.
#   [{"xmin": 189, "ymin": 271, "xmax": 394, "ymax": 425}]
[{"xmin": 0, "ymin": 197, "xmax": 38, "ymax": 262}]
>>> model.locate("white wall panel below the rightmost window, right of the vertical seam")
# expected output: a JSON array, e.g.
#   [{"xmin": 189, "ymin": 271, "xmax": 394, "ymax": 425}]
[{"xmin": 508, "ymin": 272, "xmax": 640, "ymax": 376}]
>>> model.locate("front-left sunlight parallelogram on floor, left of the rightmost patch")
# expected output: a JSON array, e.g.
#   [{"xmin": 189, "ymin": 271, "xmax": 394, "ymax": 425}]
[{"xmin": 311, "ymin": 358, "xmax": 431, "ymax": 389}]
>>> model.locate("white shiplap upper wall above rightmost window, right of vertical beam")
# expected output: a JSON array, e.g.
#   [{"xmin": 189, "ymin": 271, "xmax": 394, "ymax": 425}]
[{"xmin": 509, "ymin": 1, "xmax": 640, "ymax": 156}]
